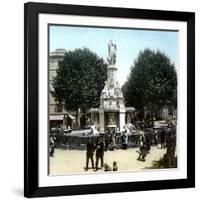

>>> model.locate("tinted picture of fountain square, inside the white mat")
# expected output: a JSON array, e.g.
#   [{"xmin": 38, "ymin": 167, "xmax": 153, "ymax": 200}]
[{"xmin": 48, "ymin": 24, "xmax": 179, "ymax": 175}]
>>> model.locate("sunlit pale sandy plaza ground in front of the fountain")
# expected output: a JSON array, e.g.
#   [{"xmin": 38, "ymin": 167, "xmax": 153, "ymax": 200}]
[{"xmin": 50, "ymin": 147, "xmax": 166, "ymax": 175}]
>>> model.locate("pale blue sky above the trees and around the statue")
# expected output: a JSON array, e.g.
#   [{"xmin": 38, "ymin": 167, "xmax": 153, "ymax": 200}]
[{"xmin": 49, "ymin": 25, "xmax": 178, "ymax": 86}]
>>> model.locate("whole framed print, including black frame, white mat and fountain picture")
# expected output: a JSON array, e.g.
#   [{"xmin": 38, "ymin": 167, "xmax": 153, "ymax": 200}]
[{"xmin": 24, "ymin": 3, "xmax": 195, "ymax": 197}]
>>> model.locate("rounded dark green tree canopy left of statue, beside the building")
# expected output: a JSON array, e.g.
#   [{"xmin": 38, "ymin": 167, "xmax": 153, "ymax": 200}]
[{"xmin": 51, "ymin": 48, "xmax": 107, "ymax": 111}]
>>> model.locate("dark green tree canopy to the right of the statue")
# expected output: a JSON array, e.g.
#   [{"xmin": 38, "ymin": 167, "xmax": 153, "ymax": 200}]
[{"xmin": 122, "ymin": 49, "xmax": 177, "ymax": 110}]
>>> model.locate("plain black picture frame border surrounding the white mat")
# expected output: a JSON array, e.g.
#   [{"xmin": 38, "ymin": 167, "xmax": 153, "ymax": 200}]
[{"xmin": 24, "ymin": 2, "xmax": 195, "ymax": 197}]
